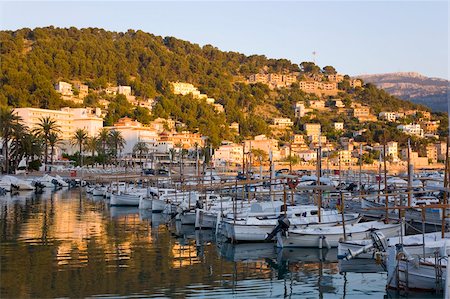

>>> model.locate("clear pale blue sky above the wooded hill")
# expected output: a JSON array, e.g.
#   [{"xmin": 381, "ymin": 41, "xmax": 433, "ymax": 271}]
[{"xmin": 0, "ymin": 1, "xmax": 450, "ymax": 79}]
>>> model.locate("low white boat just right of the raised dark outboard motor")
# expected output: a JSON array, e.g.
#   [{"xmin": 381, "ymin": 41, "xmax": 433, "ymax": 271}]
[{"xmin": 277, "ymin": 221, "xmax": 403, "ymax": 248}]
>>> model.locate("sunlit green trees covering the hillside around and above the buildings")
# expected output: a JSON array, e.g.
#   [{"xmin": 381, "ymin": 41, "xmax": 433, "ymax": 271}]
[{"xmin": 0, "ymin": 27, "xmax": 442, "ymax": 145}]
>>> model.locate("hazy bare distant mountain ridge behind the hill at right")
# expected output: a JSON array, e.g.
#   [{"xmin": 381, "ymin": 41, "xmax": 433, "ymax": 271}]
[{"xmin": 355, "ymin": 72, "xmax": 449, "ymax": 112}]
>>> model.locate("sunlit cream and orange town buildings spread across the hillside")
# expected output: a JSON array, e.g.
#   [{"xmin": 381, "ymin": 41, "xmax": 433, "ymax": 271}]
[{"xmin": 2, "ymin": 74, "xmax": 446, "ymax": 173}]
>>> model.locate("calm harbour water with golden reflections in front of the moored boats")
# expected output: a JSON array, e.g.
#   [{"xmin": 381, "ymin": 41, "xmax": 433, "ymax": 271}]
[{"xmin": 0, "ymin": 189, "xmax": 394, "ymax": 298}]
